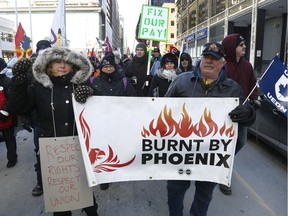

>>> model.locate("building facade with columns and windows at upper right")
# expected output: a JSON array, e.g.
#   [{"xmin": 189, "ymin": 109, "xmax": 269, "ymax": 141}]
[{"xmin": 176, "ymin": 0, "xmax": 287, "ymax": 68}]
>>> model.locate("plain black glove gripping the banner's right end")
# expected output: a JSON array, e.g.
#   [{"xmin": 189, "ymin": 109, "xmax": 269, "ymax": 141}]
[{"xmin": 229, "ymin": 105, "xmax": 253, "ymax": 124}]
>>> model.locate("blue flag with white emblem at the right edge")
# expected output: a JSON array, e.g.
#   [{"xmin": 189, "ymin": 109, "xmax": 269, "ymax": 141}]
[{"xmin": 258, "ymin": 56, "xmax": 288, "ymax": 117}]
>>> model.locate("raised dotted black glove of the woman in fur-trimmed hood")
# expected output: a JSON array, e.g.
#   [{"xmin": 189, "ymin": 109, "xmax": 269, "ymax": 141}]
[{"xmin": 12, "ymin": 58, "xmax": 32, "ymax": 82}]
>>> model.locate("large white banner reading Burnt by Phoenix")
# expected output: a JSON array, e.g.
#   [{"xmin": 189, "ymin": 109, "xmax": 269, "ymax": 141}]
[{"xmin": 73, "ymin": 96, "xmax": 239, "ymax": 186}]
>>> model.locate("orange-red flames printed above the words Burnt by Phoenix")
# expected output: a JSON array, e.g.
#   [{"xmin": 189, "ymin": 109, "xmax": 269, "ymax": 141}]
[{"xmin": 141, "ymin": 103, "xmax": 235, "ymax": 138}]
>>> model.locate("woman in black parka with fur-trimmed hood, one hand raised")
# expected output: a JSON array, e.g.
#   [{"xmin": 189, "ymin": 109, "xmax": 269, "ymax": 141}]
[{"xmin": 11, "ymin": 47, "xmax": 98, "ymax": 216}]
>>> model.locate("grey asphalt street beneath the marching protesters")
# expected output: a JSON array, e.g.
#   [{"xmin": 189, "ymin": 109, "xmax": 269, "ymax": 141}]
[{"xmin": 0, "ymin": 130, "xmax": 287, "ymax": 216}]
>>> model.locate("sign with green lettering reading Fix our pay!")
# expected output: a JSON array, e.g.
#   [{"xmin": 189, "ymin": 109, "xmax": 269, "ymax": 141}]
[{"xmin": 138, "ymin": 5, "xmax": 169, "ymax": 41}]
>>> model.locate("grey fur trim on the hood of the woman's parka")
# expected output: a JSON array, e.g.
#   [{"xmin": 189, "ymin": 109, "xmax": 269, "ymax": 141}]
[{"xmin": 33, "ymin": 47, "xmax": 93, "ymax": 88}]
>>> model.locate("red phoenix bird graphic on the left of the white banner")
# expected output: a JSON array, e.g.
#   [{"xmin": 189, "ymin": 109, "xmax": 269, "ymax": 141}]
[{"xmin": 79, "ymin": 109, "xmax": 136, "ymax": 173}]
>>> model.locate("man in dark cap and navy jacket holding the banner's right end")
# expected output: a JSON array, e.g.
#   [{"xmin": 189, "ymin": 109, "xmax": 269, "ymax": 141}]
[{"xmin": 165, "ymin": 43, "xmax": 255, "ymax": 216}]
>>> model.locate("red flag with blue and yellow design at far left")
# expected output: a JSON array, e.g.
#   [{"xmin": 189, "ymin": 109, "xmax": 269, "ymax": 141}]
[{"xmin": 15, "ymin": 23, "xmax": 32, "ymax": 59}]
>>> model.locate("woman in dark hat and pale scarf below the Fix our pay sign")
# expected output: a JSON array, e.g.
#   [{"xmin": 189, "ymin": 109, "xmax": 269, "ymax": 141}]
[{"xmin": 149, "ymin": 53, "xmax": 181, "ymax": 97}]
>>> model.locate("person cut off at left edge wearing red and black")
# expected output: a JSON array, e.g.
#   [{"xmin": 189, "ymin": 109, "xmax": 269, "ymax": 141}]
[{"xmin": 0, "ymin": 58, "xmax": 17, "ymax": 168}]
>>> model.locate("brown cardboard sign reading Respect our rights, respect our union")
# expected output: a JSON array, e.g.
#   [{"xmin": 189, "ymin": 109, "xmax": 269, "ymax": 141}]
[{"xmin": 39, "ymin": 136, "xmax": 93, "ymax": 212}]
